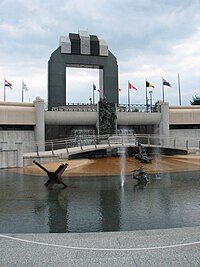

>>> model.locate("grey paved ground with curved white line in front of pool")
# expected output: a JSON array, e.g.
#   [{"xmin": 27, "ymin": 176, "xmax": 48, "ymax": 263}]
[{"xmin": 0, "ymin": 227, "xmax": 200, "ymax": 267}]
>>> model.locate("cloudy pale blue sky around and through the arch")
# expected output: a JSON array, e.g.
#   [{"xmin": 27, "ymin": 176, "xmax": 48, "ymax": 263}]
[{"xmin": 0, "ymin": 0, "xmax": 200, "ymax": 105}]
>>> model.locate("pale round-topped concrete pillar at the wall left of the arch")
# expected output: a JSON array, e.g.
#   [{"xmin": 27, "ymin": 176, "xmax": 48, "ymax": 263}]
[{"xmin": 33, "ymin": 96, "xmax": 45, "ymax": 151}]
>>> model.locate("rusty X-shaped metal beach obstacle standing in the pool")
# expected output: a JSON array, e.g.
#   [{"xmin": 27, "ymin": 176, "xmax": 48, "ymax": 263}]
[{"xmin": 33, "ymin": 160, "xmax": 68, "ymax": 189}]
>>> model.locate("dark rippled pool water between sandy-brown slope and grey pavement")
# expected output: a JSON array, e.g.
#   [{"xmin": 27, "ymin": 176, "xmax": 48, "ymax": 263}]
[{"xmin": 0, "ymin": 170, "xmax": 200, "ymax": 233}]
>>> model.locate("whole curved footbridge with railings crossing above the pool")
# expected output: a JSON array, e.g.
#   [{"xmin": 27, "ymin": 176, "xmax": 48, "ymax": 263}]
[{"xmin": 23, "ymin": 135, "xmax": 188, "ymax": 166}]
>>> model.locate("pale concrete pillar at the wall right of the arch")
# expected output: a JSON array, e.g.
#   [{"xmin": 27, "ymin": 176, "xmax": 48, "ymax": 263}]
[{"xmin": 158, "ymin": 102, "xmax": 169, "ymax": 146}]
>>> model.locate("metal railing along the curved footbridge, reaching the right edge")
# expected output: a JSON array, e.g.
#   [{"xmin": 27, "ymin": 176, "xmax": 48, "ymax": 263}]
[{"xmin": 23, "ymin": 134, "xmax": 200, "ymax": 155}]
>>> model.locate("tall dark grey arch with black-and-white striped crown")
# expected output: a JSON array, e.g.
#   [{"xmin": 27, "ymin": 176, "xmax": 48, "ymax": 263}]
[{"xmin": 48, "ymin": 31, "xmax": 119, "ymax": 110}]
